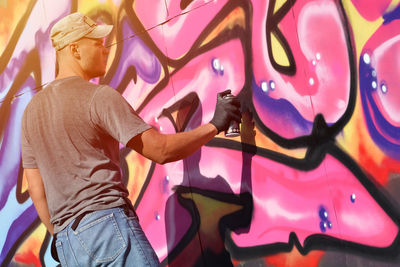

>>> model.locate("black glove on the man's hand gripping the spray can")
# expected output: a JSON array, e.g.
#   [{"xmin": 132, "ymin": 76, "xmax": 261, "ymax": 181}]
[{"xmin": 210, "ymin": 90, "xmax": 242, "ymax": 133}]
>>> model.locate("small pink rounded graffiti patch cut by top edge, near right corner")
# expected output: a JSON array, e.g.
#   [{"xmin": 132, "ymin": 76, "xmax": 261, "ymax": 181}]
[{"xmin": 351, "ymin": 0, "xmax": 392, "ymax": 21}]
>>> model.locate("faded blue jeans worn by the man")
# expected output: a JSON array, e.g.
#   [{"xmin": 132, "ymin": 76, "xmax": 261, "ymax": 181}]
[{"xmin": 56, "ymin": 208, "xmax": 160, "ymax": 267}]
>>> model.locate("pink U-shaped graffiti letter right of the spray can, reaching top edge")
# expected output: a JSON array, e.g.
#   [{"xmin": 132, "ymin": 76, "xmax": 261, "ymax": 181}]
[{"xmin": 252, "ymin": 1, "xmax": 350, "ymax": 138}]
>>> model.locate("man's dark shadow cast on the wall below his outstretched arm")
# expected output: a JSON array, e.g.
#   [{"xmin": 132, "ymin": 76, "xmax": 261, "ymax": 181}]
[{"xmin": 162, "ymin": 95, "xmax": 255, "ymax": 267}]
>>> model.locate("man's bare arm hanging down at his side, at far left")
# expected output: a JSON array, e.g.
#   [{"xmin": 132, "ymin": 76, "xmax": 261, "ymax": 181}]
[{"xmin": 25, "ymin": 169, "xmax": 54, "ymax": 235}]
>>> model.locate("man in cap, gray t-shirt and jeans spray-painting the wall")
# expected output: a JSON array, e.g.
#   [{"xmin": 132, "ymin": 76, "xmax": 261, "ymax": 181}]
[{"xmin": 21, "ymin": 13, "xmax": 241, "ymax": 266}]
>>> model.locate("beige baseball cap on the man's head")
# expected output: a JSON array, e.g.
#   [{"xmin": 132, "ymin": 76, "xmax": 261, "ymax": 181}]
[{"xmin": 50, "ymin": 12, "xmax": 113, "ymax": 50}]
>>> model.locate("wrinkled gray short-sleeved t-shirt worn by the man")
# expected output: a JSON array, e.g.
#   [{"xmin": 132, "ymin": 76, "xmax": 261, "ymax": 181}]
[{"xmin": 21, "ymin": 76, "xmax": 151, "ymax": 233}]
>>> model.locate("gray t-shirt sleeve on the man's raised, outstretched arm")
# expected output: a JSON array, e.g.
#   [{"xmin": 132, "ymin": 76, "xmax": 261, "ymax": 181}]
[{"xmin": 90, "ymin": 85, "xmax": 151, "ymax": 145}]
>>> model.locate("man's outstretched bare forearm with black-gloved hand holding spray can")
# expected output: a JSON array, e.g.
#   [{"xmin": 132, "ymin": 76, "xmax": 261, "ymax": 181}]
[{"xmin": 127, "ymin": 90, "xmax": 241, "ymax": 164}]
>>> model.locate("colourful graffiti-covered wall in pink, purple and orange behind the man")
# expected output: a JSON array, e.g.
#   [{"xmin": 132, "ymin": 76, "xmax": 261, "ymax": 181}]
[{"xmin": 0, "ymin": 0, "xmax": 400, "ymax": 266}]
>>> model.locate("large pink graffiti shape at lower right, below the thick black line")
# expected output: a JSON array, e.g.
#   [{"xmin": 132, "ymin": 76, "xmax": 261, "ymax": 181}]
[{"xmin": 225, "ymin": 151, "xmax": 398, "ymax": 247}]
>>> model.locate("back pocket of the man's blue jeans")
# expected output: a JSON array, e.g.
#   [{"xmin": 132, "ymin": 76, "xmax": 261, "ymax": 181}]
[{"xmin": 74, "ymin": 213, "xmax": 126, "ymax": 263}]
